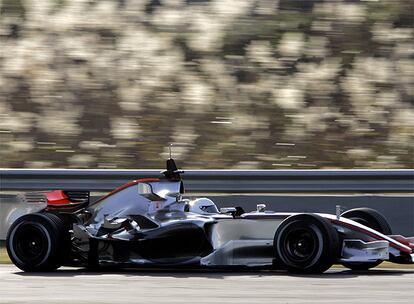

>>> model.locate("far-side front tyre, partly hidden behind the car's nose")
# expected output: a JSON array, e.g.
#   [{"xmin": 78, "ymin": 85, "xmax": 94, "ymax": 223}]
[{"xmin": 341, "ymin": 208, "xmax": 392, "ymax": 270}]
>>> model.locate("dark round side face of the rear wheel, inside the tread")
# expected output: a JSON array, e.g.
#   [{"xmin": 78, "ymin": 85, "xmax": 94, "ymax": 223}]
[{"xmin": 11, "ymin": 222, "xmax": 50, "ymax": 264}]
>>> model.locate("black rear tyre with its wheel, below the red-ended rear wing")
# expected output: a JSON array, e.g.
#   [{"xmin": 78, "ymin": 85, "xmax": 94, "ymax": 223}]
[{"xmin": 6, "ymin": 213, "xmax": 70, "ymax": 271}]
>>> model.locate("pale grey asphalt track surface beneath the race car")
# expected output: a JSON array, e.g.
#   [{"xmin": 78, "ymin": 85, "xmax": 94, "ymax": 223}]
[{"xmin": 0, "ymin": 265, "xmax": 414, "ymax": 304}]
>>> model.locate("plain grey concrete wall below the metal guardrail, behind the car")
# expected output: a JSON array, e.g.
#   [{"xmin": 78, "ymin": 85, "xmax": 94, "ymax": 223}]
[{"xmin": 0, "ymin": 194, "xmax": 414, "ymax": 240}]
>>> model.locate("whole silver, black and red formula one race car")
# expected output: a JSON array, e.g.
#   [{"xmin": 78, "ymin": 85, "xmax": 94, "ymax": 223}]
[{"xmin": 6, "ymin": 159, "xmax": 414, "ymax": 273}]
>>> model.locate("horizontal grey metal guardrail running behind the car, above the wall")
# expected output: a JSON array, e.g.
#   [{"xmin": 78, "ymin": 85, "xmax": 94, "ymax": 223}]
[{"xmin": 0, "ymin": 169, "xmax": 414, "ymax": 193}]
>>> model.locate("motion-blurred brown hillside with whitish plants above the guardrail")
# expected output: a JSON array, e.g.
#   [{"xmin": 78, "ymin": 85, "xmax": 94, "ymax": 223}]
[{"xmin": 0, "ymin": 0, "xmax": 414, "ymax": 169}]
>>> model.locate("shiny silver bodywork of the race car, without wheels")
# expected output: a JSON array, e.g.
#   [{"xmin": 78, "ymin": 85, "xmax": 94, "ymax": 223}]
[{"xmin": 65, "ymin": 181, "xmax": 412, "ymax": 266}]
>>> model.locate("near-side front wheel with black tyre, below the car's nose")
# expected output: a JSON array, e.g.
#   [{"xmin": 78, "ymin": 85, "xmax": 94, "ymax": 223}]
[{"xmin": 273, "ymin": 214, "xmax": 339, "ymax": 273}]
